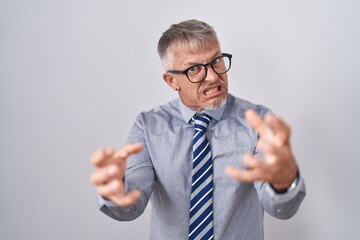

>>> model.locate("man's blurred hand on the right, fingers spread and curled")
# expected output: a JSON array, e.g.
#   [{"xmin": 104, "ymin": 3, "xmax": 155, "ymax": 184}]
[{"xmin": 225, "ymin": 110, "xmax": 298, "ymax": 191}]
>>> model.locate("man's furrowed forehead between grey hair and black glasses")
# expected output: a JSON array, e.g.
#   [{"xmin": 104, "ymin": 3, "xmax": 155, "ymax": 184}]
[{"xmin": 168, "ymin": 42, "xmax": 221, "ymax": 68}]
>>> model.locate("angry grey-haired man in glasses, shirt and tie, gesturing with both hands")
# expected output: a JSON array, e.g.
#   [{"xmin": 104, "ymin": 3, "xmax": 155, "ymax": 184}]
[{"xmin": 90, "ymin": 20, "xmax": 305, "ymax": 240}]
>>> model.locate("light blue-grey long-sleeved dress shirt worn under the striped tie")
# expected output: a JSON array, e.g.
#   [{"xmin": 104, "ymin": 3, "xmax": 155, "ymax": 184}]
[{"xmin": 98, "ymin": 94, "xmax": 305, "ymax": 240}]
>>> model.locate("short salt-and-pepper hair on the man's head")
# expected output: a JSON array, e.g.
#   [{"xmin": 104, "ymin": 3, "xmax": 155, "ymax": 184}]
[{"xmin": 157, "ymin": 19, "xmax": 219, "ymax": 67}]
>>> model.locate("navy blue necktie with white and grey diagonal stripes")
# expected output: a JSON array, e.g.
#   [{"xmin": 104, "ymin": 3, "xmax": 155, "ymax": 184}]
[{"xmin": 189, "ymin": 114, "xmax": 213, "ymax": 240}]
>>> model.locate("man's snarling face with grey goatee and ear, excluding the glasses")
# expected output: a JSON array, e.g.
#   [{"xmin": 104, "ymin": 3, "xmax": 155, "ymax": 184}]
[{"xmin": 163, "ymin": 43, "xmax": 228, "ymax": 111}]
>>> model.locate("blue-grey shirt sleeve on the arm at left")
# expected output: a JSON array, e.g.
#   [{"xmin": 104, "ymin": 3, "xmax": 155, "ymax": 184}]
[{"xmin": 97, "ymin": 115, "xmax": 155, "ymax": 221}]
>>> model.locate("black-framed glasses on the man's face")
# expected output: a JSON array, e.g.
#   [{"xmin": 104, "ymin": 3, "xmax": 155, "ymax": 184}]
[{"xmin": 167, "ymin": 53, "xmax": 232, "ymax": 83}]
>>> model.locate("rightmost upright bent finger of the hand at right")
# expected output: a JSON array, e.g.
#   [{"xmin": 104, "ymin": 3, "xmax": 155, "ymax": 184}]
[{"xmin": 264, "ymin": 114, "xmax": 291, "ymax": 146}]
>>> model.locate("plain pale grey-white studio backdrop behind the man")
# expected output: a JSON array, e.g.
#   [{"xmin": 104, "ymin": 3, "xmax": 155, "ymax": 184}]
[{"xmin": 0, "ymin": 0, "xmax": 360, "ymax": 240}]
